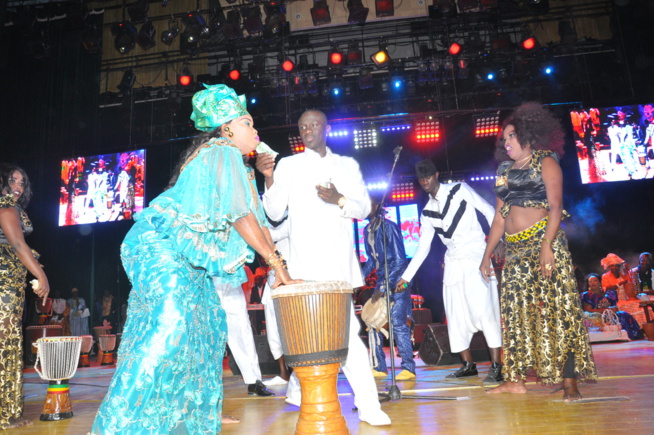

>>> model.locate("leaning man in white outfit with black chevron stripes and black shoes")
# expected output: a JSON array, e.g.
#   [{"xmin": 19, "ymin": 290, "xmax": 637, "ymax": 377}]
[{"xmin": 397, "ymin": 160, "xmax": 502, "ymax": 385}]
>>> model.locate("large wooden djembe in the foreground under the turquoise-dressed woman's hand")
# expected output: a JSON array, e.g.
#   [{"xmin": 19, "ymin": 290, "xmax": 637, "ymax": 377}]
[{"xmin": 271, "ymin": 281, "xmax": 352, "ymax": 434}]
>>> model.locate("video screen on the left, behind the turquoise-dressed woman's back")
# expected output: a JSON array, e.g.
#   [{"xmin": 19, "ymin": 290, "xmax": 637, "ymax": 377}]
[{"xmin": 59, "ymin": 150, "xmax": 145, "ymax": 226}]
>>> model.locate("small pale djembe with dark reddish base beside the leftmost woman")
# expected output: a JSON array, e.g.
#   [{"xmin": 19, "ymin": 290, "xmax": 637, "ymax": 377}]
[{"xmin": 34, "ymin": 337, "xmax": 82, "ymax": 421}]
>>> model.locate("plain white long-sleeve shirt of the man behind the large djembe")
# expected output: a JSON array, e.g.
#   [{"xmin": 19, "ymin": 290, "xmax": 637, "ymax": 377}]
[{"xmin": 263, "ymin": 148, "xmax": 370, "ymax": 287}]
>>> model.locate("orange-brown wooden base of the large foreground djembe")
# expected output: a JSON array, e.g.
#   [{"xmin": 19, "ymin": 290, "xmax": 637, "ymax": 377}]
[{"xmin": 293, "ymin": 363, "xmax": 350, "ymax": 435}]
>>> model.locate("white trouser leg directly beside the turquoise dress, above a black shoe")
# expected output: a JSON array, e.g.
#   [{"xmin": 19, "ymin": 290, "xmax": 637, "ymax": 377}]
[{"xmin": 214, "ymin": 278, "xmax": 261, "ymax": 385}]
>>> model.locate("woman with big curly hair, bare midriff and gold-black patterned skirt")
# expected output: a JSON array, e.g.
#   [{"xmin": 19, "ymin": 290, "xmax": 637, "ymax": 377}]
[{"xmin": 479, "ymin": 103, "xmax": 597, "ymax": 401}]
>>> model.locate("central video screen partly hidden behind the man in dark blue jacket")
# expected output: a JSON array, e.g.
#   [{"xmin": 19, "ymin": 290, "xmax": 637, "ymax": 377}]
[{"xmin": 354, "ymin": 204, "xmax": 420, "ymax": 263}]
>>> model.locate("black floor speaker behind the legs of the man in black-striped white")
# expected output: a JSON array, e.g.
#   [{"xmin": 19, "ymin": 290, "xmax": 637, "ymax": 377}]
[{"xmin": 418, "ymin": 323, "xmax": 490, "ymax": 366}]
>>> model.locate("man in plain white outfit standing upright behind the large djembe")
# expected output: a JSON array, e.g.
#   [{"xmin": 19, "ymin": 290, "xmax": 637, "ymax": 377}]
[{"xmin": 257, "ymin": 110, "xmax": 391, "ymax": 426}]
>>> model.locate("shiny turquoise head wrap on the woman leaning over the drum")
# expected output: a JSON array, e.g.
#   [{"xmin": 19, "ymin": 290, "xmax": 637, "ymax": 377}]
[{"xmin": 191, "ymin": 85, "xmax": 248, "ymax": 131}]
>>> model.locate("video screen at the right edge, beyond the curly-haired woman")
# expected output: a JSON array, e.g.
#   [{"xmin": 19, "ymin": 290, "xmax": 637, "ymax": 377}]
[{"xmin": 570, "ymin": 102, "xmax": 654, "ymax": 184}]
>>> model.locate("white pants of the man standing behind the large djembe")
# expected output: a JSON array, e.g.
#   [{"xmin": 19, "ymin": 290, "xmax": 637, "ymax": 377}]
[{"xmin": 286, "ymin": 304, "xmax": 381, "ymax": 414}]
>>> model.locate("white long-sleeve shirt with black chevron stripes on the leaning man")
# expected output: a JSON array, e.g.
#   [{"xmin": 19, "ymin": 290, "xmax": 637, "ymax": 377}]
[{"xmin": 402, "ymin": 183, "xmax": 495, "ymax": 281}]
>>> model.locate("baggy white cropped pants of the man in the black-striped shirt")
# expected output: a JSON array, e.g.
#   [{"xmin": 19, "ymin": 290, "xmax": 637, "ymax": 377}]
[{"xmin": 443, "ymin": 257, "xmax": 502, "ymax": 353}]
